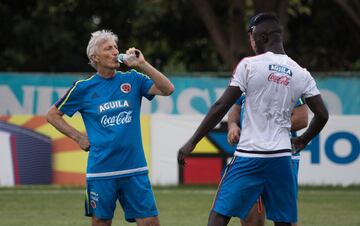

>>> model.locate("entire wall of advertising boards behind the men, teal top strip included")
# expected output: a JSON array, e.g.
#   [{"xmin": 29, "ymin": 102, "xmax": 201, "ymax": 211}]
[{"xmin": 0, "ymin": 73, "xmax": 360, "ymax": 185}]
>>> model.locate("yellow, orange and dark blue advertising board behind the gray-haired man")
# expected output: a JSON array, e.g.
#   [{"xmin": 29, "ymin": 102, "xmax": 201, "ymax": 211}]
[{"xmin": 0, "ymin": 114, "xmax": 151, "ymax": 186}]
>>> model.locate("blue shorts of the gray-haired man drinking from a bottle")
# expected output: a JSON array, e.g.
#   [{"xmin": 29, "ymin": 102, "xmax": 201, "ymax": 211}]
[{"xmin": 85, "ymin": 174, "xmax": 158, "ymax": 222}]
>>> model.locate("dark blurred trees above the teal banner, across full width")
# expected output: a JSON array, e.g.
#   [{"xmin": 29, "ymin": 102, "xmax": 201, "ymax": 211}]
[{"xmin": 0, "ymin": 0, "xmax": 360, "ymax": 72}]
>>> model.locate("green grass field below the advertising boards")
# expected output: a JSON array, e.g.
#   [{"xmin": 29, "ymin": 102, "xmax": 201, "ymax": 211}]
[{"xmin": 0, "ymin": 186, "xmax": 360, "ymax": 226}]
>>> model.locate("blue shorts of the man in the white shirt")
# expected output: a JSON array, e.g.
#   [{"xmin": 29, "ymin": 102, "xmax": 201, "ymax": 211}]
[{"xmin": 213, "ymin": 156, "xmax": 297, "ymax": 223}]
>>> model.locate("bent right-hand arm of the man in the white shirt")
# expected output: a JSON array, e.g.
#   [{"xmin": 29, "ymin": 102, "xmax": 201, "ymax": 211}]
[{"xmin": 292, "ymin": 94, "xmax": 329, "ymax": 150}]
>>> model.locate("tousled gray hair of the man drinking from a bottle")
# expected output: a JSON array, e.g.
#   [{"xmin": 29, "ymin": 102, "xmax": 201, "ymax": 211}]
[{"xmin": 86, "ymin": 30, "xmax": 118, "ymax": 69}]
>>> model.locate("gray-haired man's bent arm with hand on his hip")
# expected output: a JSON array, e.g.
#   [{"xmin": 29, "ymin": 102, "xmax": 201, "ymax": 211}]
[{"xmin": 46, "ymin": 105, "xmax": 90, "ymax": 151}]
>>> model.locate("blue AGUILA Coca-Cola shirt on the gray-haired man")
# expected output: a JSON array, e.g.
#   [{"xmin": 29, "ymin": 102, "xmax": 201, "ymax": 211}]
[{"xmin": 55, "ymin": 70, "xmax": 154, "ymax": 180}]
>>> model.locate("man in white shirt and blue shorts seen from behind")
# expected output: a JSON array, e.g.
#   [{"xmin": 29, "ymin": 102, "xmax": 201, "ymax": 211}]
[{"xmin": 178, "ymin": 13, "xmax": 328, "ymax": 226}]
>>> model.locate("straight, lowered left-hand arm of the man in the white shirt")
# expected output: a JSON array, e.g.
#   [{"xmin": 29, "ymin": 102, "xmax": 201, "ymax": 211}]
[{"xmin": 178, "ymin": 86, "xmax": 242, "ymax": 165}]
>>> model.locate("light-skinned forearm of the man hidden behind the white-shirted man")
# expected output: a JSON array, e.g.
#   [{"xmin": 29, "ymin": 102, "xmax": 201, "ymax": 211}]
[{"xmin": 227, "ymin": 104, "xmax": 241, "ymax": 145}]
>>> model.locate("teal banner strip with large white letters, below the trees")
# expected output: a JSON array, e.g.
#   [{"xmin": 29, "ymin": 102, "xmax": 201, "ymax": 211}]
[{"xmin": 0, "ymin": 73, "xmax": 360, "ymax": 115}]
